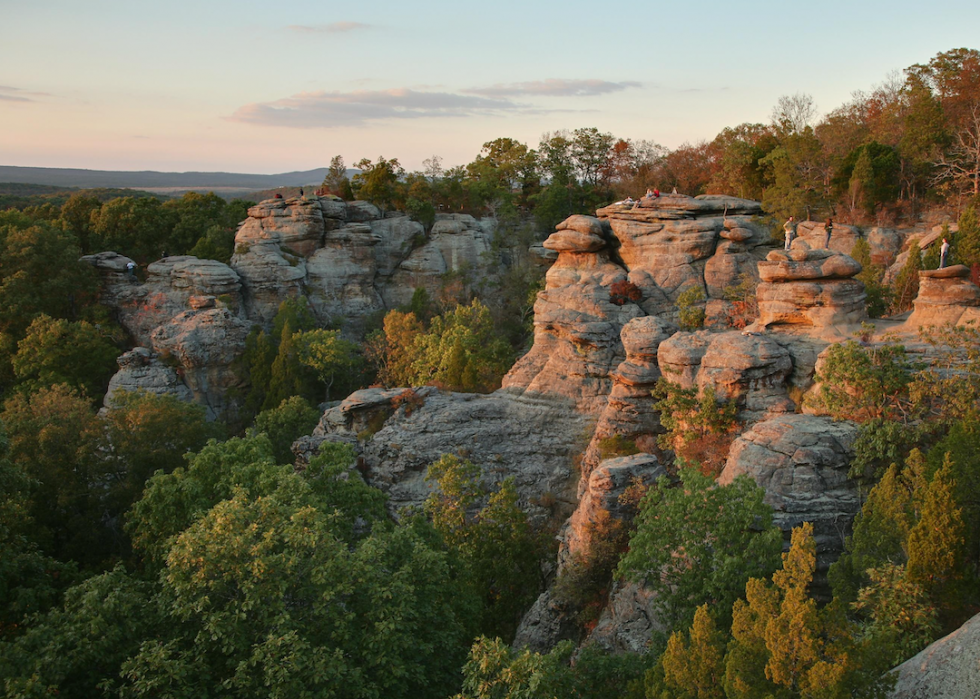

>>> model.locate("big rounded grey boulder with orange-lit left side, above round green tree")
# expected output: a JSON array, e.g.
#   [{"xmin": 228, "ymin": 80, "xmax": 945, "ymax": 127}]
[{"xmin": 718, "ymin": 414, "xmax": 861, "ymax": 598}]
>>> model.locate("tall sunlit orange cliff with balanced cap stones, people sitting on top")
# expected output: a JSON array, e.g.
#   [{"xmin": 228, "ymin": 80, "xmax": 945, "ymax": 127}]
[{"xmin": 504, "ymin": 195, "xmax": 769, "ymax": 415}]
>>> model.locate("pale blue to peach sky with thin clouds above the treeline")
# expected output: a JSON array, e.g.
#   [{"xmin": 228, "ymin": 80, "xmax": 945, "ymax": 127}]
[{"xmin": 0, "ymin": 0, "xmax": 980, "ymax": 173}]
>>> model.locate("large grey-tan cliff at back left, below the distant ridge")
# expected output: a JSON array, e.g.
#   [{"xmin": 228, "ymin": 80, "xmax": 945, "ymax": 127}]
[{"xmin": 231, "ymin": 197, "xmax": 493, "ymax": 333}]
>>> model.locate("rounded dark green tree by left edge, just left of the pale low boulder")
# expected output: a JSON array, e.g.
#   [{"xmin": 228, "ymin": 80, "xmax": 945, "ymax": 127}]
[{"xmin": 13, "ymin": 313, "xmax": 119, "ymax": 400}]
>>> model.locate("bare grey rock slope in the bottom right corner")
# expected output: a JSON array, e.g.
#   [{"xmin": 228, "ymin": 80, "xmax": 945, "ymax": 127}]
[{"xmin": 888, "ymin": 615, "xmax": 980, "ymax": 699}]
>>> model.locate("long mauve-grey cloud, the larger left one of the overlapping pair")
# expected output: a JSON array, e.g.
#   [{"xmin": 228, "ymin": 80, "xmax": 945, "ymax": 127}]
[{"xmin": 228, "ymin": 88, "xmax": 527, "ymax": 129}]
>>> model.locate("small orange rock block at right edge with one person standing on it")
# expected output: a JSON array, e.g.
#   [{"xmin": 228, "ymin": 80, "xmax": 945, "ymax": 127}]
[{"xmin": 905, "ymin": 265, "xmax": 980, "ymax": 328}]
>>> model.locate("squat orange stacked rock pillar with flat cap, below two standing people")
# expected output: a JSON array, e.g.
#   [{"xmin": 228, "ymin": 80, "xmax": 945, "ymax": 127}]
[{"xmin": 757, "ymin": 249, "xmax": 867, "ymax": 336}]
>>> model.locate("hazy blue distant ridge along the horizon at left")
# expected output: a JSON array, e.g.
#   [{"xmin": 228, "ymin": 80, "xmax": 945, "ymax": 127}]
[{"xmin": 0, "ymin": 165, "xmax": 327, "ymax": 190}]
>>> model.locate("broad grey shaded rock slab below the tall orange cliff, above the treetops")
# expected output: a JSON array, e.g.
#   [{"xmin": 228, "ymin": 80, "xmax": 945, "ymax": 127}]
[{"xmin": 300, "ymin": 388, "xmax": 589, "ymax": 518}]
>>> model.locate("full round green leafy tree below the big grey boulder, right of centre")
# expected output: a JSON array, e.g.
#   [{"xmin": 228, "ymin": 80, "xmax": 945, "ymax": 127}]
[{"xmin": 618, "ymin": 468, "xmax": 782, "ymax": 631}]
